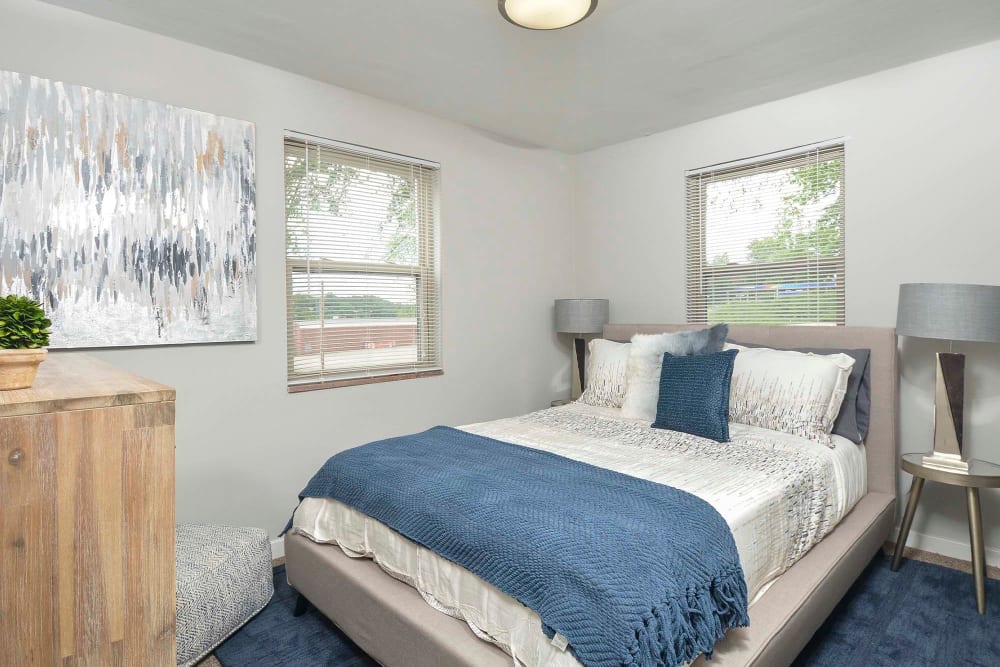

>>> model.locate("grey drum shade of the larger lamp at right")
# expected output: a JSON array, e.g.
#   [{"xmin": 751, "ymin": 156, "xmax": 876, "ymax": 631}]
[{"xmin": 896, "ymin": 283, "xmax": 1000, "ymax": 343}]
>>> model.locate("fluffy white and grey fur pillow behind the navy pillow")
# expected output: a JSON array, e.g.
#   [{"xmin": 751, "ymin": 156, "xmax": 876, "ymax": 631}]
[{"xmin": 622, "ymin": 324, "xmax": 739, "ymax": 423}]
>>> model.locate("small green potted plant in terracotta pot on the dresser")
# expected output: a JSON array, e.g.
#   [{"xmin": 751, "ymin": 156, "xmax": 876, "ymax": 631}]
[{"xmin": 0, "ymin": 294, "xmax": 52, "ymax": 390}]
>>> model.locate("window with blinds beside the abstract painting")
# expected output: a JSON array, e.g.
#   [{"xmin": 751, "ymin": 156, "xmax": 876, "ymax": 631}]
[{"xmin": 285, "ymin": 133, "xmax": 442, "ymax": 391}]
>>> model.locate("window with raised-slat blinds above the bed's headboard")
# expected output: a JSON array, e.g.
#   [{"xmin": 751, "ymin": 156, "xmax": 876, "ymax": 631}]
[{"xmin": 687, "ymin": 141, "xmax": 844, "ymax": 325}]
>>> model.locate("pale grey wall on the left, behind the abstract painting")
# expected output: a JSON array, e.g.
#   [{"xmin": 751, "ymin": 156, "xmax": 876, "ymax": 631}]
[{"xmin": 0, "ymin": 0, "xmax": 573, "ymax": 536}]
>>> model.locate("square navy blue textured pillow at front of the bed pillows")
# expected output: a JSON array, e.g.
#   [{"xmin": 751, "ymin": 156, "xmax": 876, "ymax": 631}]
[{"xmin": 653, "ymin": 350, "xmax": 737, "ymax": 442}]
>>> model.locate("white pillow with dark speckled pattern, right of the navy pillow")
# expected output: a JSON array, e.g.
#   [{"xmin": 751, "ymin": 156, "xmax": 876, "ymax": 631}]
[{"xmin": 726, "ymin": 344, "xmax": 854, "ymax": 446}]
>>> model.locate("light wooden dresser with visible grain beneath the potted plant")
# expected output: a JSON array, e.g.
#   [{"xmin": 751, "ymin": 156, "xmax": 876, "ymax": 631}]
[{"xmin": 0, "ymin": 352, "xmax": 176, "ymax": 667}]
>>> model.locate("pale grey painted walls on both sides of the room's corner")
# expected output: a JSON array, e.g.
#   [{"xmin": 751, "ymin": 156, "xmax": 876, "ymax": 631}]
[{"xmin": 7, "ymin": 0, "xmax": 1000, "ymax": 563}]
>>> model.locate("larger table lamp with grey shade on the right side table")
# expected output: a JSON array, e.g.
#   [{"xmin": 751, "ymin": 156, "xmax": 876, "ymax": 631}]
[{"xmin": 896, "ymin": 283, "xmax": 1000, "ymax": 472}]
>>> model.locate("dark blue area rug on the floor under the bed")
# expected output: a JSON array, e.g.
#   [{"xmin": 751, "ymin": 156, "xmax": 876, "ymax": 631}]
[{"xmin": 215, "ymin": 555, "xmax": 1000, "ymax": 667}]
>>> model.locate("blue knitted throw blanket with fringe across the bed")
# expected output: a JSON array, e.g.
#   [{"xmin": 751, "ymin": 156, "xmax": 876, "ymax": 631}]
[{"xmin": 290, "ymin": 426, "xmax": 749, "ymax": 667}]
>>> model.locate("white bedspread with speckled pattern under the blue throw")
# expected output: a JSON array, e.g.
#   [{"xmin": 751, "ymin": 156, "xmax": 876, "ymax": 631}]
[{"xmin": 293, "ymin": 403, "xmax": 867, "ymax": 667}]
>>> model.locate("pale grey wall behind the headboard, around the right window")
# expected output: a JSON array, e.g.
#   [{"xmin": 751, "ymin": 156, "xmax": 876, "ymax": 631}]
[{"xmin": 576, "ymin": 42, "xmax": 1000, "ymax": 563}]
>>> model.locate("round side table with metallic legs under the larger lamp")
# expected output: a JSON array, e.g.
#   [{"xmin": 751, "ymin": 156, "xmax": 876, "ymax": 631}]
[{"xmin": 892, "ymin": 454, "xmax": 1000, "ymax": 614}]
